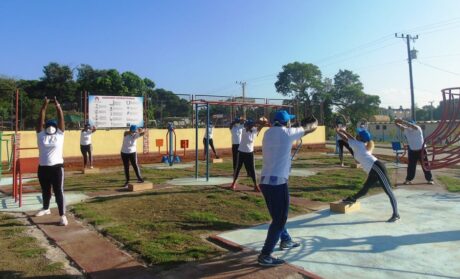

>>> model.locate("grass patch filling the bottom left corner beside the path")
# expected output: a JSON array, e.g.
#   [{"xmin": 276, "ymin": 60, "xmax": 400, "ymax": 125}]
[{"xmin": 0, "ymin": 213, "xmax": 70, "ymax": 278}]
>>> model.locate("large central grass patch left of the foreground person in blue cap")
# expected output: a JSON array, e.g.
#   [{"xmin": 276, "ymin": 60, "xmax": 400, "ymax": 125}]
[{"xmin": 73, "ymin": 187, "xmax": 306, "ymax": 268}]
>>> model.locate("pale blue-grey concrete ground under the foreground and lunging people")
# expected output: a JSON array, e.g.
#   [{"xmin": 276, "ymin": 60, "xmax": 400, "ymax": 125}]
[{"xmin": 219, "ymin": 188, "xmax": 460, "ymax": 278}]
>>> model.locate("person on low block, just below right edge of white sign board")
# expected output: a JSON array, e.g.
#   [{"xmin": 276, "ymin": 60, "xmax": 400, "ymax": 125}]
[{"xmin": 121, "ymin": 125, "xmax": 145, "ymax": 187}]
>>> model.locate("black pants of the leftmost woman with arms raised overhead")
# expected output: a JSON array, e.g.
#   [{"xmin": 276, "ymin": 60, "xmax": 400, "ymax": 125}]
[{"xmin": 38, "ymin": 164, "xmax": 65, "ymax": 216}]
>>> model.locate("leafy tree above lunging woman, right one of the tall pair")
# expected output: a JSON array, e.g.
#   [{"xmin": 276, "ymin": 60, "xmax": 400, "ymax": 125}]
[{"xmin": 328, "ymin": 70, "xmax": 380, "ymax": 124}]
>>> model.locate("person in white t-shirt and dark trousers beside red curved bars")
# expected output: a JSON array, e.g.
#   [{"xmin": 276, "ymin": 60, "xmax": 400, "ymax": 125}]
[{"xmin": 395, "ymin": 119, "xmax": 434, "ymax": 185}]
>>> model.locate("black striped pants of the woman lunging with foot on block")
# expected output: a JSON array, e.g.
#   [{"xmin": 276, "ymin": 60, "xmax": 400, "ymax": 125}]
[{"xmin": 353, "ymin": 160, "xmax": 399, "ymax": 215}]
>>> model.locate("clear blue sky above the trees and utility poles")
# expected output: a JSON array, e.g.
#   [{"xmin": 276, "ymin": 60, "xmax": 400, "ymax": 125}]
[{"xmin": 0, "ymin": 0, "xmax": 460, "ymax": 107}]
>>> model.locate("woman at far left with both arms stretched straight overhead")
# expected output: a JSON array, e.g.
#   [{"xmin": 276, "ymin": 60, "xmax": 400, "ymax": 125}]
[{"xmin": 35, "ymin": 97, "xmax": 68, "ymax": 226}]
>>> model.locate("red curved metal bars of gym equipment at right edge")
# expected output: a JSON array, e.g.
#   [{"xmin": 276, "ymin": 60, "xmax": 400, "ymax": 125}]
[{"xmin": 422, "ymin": 87, "xmax": 460, "ymax": 170}]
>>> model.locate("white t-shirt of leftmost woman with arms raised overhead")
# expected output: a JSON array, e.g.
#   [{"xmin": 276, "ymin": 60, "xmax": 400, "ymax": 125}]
[{"xmin": 37, "ymin": 129, "xmax": 64, "ymax": 166}]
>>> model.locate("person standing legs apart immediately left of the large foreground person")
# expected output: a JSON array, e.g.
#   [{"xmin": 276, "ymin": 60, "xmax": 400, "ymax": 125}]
[{"xmin": 231, "ymin": 119, "xmax": 266, "ymax": 192}]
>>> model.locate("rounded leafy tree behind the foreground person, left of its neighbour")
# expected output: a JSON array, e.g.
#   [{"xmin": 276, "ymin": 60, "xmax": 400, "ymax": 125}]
[{"xmin": 275, "ymin": 62, "xmax": 323, "ymax": 115}]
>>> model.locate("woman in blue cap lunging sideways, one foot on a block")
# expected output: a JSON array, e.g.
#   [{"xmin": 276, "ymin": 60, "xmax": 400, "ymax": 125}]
[{"xmin": 336, "ymin": 129, "xmax": 400, "ymax": 222}]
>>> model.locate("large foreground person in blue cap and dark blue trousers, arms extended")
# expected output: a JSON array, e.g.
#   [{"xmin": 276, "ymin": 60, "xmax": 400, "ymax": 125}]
[{"xmin": 257, "ymin": 110, "xmax": 318, "ymax": 266}]
